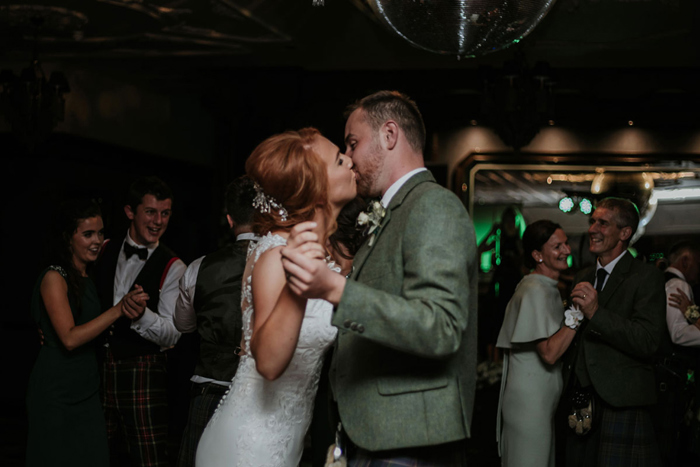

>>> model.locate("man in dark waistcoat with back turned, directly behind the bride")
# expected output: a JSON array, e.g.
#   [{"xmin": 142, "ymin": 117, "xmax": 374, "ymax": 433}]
[{"xmin": 173, "ymin": 177, "xmax": 257, "ymax": 467}]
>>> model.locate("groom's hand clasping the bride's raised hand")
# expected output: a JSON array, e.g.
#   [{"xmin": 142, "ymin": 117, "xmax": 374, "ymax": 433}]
[{"xmin": 282, "ymin": 249, "xmax": 345, "ymax": 306}]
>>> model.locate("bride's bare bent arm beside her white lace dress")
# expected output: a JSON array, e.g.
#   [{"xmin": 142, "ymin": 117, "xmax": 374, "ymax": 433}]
[{"xmin": 250, "ymin": 248, "xmax": 306, "ymax": 380}]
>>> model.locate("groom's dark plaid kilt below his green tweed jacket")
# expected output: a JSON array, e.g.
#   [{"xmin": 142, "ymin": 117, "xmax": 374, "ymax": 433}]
[{"xmin": 348, "ymin": 440, "xmax": 467, "ymax": 467}]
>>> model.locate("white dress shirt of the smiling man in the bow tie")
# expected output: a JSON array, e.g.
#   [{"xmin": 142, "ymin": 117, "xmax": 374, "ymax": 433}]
[{"xmin": 113, "ymin": 232, "xmax": 186, "ymax": 351}]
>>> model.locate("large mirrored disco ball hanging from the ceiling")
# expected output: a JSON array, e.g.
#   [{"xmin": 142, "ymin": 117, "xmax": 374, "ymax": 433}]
[{"xmin": 368, "ymin": 0, "xmax": 555, "ymax": 57}]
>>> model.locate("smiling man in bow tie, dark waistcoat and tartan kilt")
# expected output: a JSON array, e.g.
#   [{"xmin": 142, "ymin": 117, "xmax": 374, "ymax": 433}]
[{"xmin": 96, "ymin": 177, "xmax": 185, "ymax": 467}]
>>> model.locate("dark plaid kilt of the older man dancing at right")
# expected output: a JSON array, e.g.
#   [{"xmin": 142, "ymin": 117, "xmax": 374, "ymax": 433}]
[{"xmin": 598, "ymin": 407, "xmax": 661, "ymax": 467}]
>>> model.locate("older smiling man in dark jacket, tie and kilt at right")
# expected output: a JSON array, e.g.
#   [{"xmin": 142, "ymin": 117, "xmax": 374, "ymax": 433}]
[{"xmin": 564, "ymin": 198, "xmax": 666, "ymax": 466}]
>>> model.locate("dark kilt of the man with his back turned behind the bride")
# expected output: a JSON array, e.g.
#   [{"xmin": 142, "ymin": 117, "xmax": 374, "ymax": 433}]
[{"xmin": 177, "ymin": 383, "xmax": 228, "ymax": 467}]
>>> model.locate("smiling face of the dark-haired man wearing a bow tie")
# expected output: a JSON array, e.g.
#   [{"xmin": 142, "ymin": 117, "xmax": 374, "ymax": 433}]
[{"xmin": 124, "ymin": 195, "xmax": 173, "ymax": 247}]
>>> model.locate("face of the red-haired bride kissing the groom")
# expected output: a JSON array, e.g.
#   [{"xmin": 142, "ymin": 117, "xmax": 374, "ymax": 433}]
[{"xmin": 313, "ymin": 135, "xmax": 357, "ymax": 207}]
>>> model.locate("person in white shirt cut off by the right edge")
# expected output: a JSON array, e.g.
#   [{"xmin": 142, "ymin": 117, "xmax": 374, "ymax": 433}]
[{"xmin": 653, "ymin": 241, "xmax": 700, "ymax": 467}]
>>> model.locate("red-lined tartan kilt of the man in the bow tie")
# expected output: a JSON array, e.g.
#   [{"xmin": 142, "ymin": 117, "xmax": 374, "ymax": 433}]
[{"xmin": 102, "ymin": 349, "xmax": 169, "ymax": 467}]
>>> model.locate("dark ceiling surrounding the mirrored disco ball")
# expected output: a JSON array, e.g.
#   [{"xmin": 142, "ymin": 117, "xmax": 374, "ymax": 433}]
[{"xmin": 0, "ymin": 0, "xmax": 700, "ymax": 70}]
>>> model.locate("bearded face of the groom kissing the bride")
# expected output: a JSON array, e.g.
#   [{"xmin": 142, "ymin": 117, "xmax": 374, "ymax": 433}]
[{"xmin": 345, "ymin": 109, "xmax": 383, "ymax": 197}]
